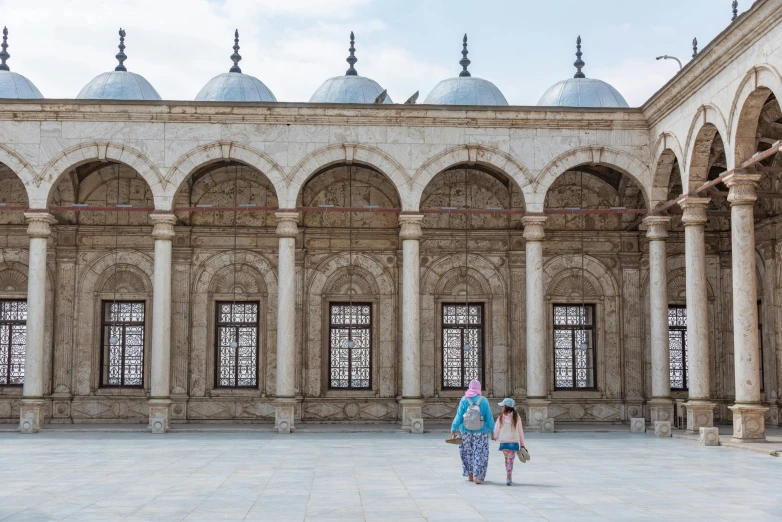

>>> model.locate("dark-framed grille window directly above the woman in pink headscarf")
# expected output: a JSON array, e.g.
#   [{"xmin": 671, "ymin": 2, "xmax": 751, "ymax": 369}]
[{"xmin": 442, "ymin": 303, "xmax": 484, "ymax": 390}]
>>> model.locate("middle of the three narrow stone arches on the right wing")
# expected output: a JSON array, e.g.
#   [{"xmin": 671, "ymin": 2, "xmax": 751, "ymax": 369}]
[{"xmin": 681, "ymin": 104, "xmax": 733, "ymax": 191}]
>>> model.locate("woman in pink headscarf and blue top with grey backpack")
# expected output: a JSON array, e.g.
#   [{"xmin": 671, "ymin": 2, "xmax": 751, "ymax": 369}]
[{"xmin": 451, "ymin": 380, "xmax": 494, "ymax": 484}]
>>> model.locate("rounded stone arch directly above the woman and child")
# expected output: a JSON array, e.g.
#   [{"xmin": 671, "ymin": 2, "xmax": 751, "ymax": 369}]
[{"xmin": 410, "ymin": 145, "xmax": 532, "ymax": 211}]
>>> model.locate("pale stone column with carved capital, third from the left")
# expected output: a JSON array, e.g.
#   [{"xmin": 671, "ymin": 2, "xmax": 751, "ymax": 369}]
[{"xmin": 274, "ymin": 211, "xmax": 299, "ymax": 433}]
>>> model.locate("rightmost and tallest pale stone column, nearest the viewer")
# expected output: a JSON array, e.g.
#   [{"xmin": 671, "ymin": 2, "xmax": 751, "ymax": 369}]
[{"xmin": 725, "ymin": 174, "xmax": 768, "ymax": 442}]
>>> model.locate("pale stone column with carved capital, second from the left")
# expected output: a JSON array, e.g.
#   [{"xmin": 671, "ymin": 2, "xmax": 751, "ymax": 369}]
[{"xmin": 149, "ymin": 214, "xmax": 176, "ymax": 433}]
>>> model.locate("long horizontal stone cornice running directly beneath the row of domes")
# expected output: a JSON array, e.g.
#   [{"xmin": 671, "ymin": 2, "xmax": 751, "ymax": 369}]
[{"xmin": 0, "ymin": 100, "xmax": 649, "ymax": 130}]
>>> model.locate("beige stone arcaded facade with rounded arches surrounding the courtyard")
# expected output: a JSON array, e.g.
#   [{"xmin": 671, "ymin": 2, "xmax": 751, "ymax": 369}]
[{"xmin": 0, "ymin": 1, "xmax": 782, "ymax": 438}]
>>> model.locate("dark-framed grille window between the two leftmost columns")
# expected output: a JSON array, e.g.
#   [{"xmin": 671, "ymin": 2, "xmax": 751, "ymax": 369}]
[{"xmin": 101, "ymin": 301, "xmax": 145, "ymax": 388}]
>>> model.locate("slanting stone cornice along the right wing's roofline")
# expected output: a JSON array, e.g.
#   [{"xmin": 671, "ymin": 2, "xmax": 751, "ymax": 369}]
[{"xmin": 641, "ymin": 0, "xmax": 782, "ymax": 127}]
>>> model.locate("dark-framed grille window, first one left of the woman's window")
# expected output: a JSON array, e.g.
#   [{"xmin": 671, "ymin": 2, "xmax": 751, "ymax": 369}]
[{"xmin": 329, "ymin": 303, "xmax": 372, "ymax": 390}]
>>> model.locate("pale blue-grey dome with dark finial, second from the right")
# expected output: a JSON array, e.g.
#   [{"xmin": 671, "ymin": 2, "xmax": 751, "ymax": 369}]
[{"xmin": 424, "ymin": 34, "xmax": 508, "ymax": 106}]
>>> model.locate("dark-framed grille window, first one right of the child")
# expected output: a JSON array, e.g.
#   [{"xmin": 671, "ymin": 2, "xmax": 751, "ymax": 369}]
[{"xmin": 554, "ymin": 304, "xmax": 596, "ymax": 390}]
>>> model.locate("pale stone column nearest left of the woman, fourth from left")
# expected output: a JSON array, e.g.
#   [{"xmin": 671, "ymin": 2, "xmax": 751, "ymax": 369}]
[{"xmin": 399, "ymin": 214, "xmax": 424, "ymax": 429}]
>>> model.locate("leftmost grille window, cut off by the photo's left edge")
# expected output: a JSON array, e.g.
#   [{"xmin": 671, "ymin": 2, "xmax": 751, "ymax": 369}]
[{"xmin": 0, "ymin": 301, "xmax": 27, "ymax": 386}]
